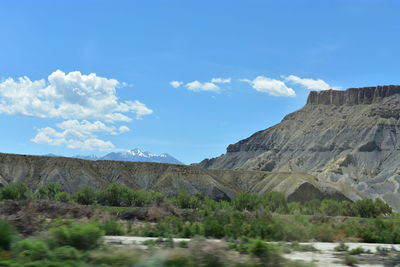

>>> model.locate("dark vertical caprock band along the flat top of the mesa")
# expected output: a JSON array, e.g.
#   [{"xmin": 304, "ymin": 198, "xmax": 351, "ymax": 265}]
[{"xmin": 307, "ymin": 85, "xmax": 400, "ymax": 106}]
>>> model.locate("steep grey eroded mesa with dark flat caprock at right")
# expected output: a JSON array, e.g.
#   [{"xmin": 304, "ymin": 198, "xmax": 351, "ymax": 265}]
[{"xmin": 199, "ymin": 85, "xmax": 400, "ymax": 210}]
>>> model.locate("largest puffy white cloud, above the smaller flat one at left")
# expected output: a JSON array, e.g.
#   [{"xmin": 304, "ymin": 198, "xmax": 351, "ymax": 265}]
[{"xmin": 0, "ymin": 70, "xmax": 153, "ymax": 122}]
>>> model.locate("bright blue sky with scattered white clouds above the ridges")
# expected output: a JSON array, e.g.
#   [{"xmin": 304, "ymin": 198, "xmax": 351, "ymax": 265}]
[{"xmin": 0, "ymin": 0, "xmax": 400, "ymax": 163}]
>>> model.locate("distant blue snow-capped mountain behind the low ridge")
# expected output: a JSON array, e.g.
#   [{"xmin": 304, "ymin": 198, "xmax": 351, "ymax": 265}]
[{"xmin": 73, "ymin": 148, "xmax": 183, "ymax": 164}]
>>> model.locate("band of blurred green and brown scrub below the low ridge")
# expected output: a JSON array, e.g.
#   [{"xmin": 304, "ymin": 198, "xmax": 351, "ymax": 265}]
[{"xmin": 0, "ymin": 184, "xmax": 400, "ymax": 266}]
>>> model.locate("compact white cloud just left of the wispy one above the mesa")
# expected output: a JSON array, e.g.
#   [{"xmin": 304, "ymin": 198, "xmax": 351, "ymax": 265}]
[{"xmin": 241, "ymin": 76, "xmax": 296, "ymax": 97}]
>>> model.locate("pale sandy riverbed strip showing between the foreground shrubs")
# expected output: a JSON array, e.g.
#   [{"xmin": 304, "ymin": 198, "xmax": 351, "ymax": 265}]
[{"xmin": 104, "ymin": 236, "xmax": 400, "ymax": 267}]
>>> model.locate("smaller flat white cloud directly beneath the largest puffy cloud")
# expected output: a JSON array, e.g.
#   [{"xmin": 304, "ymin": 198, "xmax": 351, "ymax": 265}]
[{"xmin": 32, "ymin": 120, "xmax": 129, "ymax": 151}]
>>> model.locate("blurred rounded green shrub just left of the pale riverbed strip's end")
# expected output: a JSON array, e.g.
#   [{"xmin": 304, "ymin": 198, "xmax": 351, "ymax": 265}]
[{"xmin": 50, "ymin": 223, "xmax": 104, "ymax": 250}]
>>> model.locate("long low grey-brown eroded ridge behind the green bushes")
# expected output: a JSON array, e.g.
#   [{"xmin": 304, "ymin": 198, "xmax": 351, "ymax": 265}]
[{"xmin": 0, "ymin": 154, "xmax": 362, "ymax": 201}]
